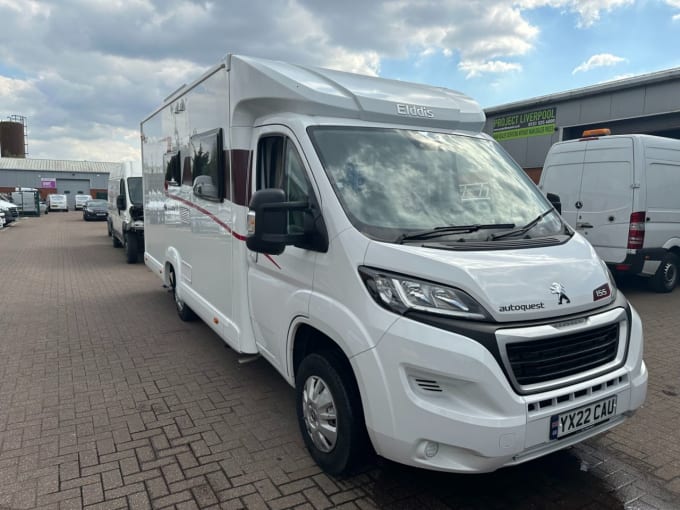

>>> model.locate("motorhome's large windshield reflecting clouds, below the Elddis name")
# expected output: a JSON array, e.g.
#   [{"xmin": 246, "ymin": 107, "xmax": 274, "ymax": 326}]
[{"xmin": 309, "ymin": 126, "xmax": 562, "ymax": 241}]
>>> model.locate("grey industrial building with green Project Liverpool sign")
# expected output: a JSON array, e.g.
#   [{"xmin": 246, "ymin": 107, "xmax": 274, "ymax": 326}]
[{"xmin": 484, "ymin": 68, "xmax": 680, "ymax": 182}]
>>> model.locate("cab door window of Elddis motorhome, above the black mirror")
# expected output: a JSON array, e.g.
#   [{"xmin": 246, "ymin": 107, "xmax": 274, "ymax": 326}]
[{"xmin": 257, "ymin": 135, "xmax": 309, "ymax": 233}]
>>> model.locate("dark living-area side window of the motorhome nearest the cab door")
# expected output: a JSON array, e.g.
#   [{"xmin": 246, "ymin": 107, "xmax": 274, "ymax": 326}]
[{"xmin": 191, "ymin": 129, "xmax": 225, "ymax": 201}]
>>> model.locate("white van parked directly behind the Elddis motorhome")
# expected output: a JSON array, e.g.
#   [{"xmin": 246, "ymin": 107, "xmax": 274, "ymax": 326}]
[{"xmin": 107, "ymin": 162, "xmax": 144, "ymax": 264}]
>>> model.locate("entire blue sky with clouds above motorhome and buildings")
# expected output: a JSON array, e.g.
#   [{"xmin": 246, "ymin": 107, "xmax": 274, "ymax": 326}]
[{"xmin": 0, "ymin": 0, "xmax": 680, "ymax": 161}]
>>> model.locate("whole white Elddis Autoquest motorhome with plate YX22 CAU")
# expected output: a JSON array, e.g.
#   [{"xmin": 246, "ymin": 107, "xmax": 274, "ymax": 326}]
[{"xmin": 141, "ymin": 56, "xmax": 647, "ymax": 473}]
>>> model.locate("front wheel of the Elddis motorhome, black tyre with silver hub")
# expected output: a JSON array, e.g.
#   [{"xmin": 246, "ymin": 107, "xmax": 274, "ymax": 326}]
[{"xmin": 295, "ymin": 352, "xmax": 369, "ymax": 475}]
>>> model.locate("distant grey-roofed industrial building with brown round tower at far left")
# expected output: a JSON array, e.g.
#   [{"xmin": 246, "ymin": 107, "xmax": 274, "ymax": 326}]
[{"xmin": 0, "ymin": 115, "xmax": 120, "ymax": 209}]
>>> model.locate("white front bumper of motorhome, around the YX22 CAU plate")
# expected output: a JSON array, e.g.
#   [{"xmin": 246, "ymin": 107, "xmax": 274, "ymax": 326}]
[{"xmin": 352, "ymin": 302, "xmax": 647, "ymax": 472}]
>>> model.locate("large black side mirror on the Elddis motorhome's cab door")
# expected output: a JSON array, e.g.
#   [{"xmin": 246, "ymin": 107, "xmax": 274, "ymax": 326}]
[{"xmin": 246, "ymin": 188, "xmax": 309, "ymax": 255}]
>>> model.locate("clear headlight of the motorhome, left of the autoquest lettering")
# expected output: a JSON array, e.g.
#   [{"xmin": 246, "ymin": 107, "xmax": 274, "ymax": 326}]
[{"xmin": 359, "ymin": 266, "xmax": 491, "ymax": 320}]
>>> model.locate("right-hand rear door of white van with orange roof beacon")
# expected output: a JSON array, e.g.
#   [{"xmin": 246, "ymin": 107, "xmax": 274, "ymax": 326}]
[{"xmin": 575, "ymin": 137, "xmax": 637, "ymax": 263}]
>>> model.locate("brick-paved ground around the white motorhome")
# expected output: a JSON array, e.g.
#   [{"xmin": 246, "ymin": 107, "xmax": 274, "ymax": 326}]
[{"xmin": 0, "ymin": 212, "xmax": 680, "ymax": 509}]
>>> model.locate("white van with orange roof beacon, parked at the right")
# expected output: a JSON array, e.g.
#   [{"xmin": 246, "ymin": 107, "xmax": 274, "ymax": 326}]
[{"xmin": 539, "ymin": 129, "xmax": 680, "ymax": 292}]
